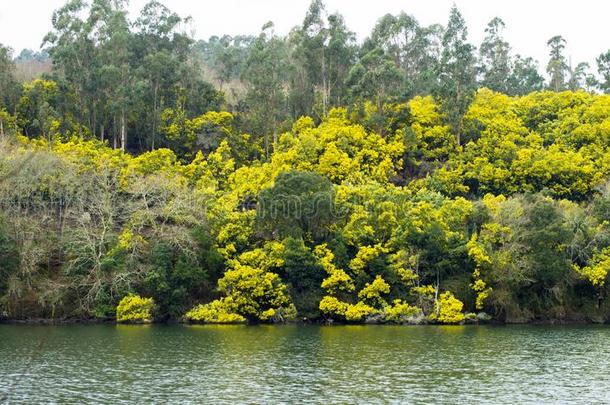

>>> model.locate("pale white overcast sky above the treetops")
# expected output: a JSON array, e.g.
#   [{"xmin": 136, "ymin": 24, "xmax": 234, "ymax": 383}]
[{"xmin": 0, "ymin": 0, "xmax": 610, "ymax": 67}]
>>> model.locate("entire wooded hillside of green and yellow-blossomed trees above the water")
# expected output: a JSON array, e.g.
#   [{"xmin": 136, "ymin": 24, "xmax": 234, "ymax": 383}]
[{"xmin": 0, "ymin": 0, "xmax": 610, "ymax": 323}]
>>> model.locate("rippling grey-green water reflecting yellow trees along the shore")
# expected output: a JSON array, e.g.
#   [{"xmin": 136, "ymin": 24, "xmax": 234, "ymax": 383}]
[{"xmin": 0, "ymin": 325, "xmax": 610, "ymax": 404}]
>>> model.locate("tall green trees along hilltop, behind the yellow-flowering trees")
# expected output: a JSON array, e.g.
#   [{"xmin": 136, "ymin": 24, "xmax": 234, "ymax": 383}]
[{"xmin": 0, "ymin": 0, "xmax": 610, "ymax": 157}]
